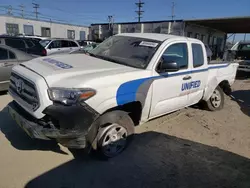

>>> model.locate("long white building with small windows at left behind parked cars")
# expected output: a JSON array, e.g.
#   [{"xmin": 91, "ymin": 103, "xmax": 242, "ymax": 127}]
[{"xmin": 0, "ymin": 15, "xmax": 89, "ymax": 40}]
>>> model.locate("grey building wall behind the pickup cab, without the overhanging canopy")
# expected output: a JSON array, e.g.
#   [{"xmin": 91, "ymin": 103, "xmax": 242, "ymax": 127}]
[{"xmin": 90, "ymin": 20, "xmax": 227, "ymax": 56}]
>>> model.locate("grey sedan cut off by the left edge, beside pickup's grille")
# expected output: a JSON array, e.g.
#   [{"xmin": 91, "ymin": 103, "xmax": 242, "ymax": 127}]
[{"xmin": 0, "ymin": 45, "xmax": 36, "ymax": 91}]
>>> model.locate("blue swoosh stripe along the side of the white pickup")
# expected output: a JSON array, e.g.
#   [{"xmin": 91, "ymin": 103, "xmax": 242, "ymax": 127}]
[{"xmin": 116, "ymin": 64, "xmax": 229, "ymax": 105}]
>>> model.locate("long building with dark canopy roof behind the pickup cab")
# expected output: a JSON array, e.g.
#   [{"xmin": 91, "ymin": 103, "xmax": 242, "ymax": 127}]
[{"xmin": 90, "ymin": 17, "xmax": 250, "ymax": 58}]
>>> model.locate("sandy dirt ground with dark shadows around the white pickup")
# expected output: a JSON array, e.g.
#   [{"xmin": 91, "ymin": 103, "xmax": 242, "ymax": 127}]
[{"xmin": 0, "ymin": 74, "xmax": 250, "ymax": 188}]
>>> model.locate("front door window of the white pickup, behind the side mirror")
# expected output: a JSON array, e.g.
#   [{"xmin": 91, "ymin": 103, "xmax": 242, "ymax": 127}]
[{"xmin": 162, "ymin": 43, "xmax": 188, "ymax": 69}]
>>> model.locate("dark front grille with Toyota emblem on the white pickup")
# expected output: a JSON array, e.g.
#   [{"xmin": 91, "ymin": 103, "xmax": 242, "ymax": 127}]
[{"xmin": 9, "ymin": 72, "xmax": 39, "ymax": 111}]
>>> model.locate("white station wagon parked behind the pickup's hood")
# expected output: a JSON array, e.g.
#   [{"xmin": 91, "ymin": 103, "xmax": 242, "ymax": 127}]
[{"xmin": 40, "ymin": 39, "xmax": 81, "ymax": 55}]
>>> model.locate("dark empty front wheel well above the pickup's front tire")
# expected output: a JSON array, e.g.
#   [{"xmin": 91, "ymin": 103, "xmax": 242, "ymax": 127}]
[{"xmin": 105, "ymin": 101, "xmax": 142, "ymax": 125}]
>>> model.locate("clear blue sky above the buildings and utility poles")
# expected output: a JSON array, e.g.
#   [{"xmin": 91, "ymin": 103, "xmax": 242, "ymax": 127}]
[{"xmin": 0, "ymin": 0, "xmax": 250, "ymax": 40}]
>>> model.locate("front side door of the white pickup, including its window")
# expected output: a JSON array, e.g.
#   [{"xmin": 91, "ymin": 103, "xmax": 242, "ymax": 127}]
[{"xmin": 150, "ymin": 42, "xmax": 191, "ymax": 118}]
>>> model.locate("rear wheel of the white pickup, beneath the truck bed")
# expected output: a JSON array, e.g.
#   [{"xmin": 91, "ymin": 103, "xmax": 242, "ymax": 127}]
[{"xmin": 206, "ymin": 86, "xmax": 224, "ymax": 111}]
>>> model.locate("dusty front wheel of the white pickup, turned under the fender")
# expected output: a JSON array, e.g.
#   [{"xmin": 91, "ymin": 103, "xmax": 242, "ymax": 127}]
[{"xmin": 97, "ymin": 111, "xmax": 134, "ymax": 159}]
